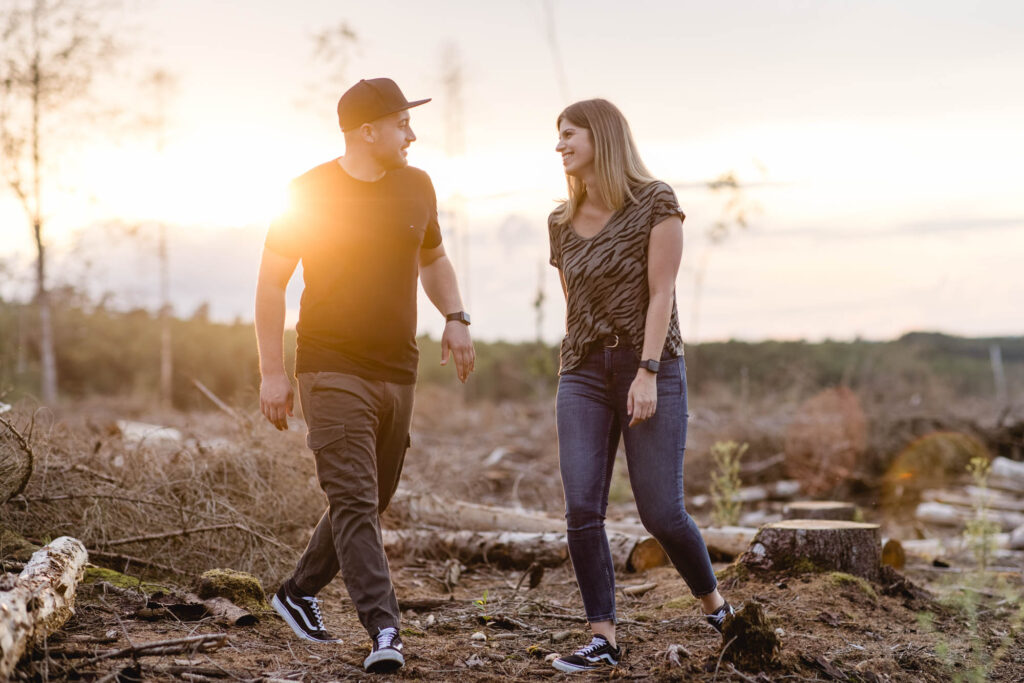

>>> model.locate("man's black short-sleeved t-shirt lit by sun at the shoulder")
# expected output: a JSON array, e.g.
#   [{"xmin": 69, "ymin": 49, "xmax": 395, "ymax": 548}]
[{"xmin": 265, "ymin": 161, "xmax": 441, "ymax": 384}]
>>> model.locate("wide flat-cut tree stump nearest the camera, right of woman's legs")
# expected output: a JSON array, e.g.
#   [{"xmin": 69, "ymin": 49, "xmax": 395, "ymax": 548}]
[{"xmin": 739, "ymin": 519, "xmax": 882, "ymax": 580}]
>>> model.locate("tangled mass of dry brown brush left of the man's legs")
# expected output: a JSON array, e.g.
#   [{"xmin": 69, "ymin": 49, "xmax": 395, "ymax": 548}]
[{"xmin": 2, "ymin": 401, "xmax": 324, "ymax": 582}]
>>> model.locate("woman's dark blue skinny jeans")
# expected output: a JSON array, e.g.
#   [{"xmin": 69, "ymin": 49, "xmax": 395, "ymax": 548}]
[{"xmin": 557, "ymin": 347, "xmax": 718, "ymax": 623}]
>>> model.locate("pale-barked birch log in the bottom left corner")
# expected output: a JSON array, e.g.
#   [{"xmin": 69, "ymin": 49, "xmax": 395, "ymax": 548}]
[{"xmin": 0, "ymin": 536, "xmax": 89, "ymax": 679}]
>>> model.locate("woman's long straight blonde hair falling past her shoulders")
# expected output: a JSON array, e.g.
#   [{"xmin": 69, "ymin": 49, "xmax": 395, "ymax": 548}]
[{"xmin": 554, "ymin": 99, "xmax": 654, "ymax": 226}]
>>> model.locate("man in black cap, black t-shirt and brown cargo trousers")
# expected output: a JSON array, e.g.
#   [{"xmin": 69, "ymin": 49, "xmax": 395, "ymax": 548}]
[{"xmin": 256, "ymin": 78, "xmax": 475, "ymax": 672}]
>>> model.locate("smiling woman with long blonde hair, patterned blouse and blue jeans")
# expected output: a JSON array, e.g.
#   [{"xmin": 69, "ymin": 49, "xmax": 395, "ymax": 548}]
[{"xmin": 548, "ymin": 99, "xmax": 732, "ymax": 672}]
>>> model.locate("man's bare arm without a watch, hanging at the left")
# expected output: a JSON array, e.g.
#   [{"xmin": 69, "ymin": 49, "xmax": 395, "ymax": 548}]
[{"xmin": 256, "ymin": 249, "xmax": 299, "ymax": 430}]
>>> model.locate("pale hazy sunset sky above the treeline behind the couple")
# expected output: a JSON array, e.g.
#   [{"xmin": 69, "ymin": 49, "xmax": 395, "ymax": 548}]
[{"xmin": 0, "ymin": 0, "xmax": 1024, "ymax": 341}]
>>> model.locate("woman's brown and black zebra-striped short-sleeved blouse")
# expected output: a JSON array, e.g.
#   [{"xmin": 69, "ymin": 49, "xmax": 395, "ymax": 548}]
[{"xmin": 548, "ymin": 180, "xmax": 686, "ymax": 375}]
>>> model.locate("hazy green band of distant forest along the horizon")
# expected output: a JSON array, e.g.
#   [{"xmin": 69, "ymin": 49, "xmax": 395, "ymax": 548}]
[{"xmin": 0, "ymin": 291, "xmax": 1024, "ymax": 410}]
